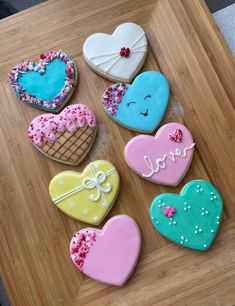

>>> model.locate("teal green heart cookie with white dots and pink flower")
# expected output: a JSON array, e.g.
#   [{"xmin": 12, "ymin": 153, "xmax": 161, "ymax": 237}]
[{"xmin": 150, "ymin": 180, "xmax": 223, "ymax": 251}]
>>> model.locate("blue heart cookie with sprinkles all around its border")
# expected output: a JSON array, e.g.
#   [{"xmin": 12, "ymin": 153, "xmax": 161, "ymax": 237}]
[{"xmin": 8, "ymin": 51, "xmax": 77, "ymax": 112}]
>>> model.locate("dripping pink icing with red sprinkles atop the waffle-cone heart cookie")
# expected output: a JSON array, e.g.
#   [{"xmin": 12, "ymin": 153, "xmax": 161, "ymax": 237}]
[{"xmin": 28, "ymin": 104, "xmax": 96, "ymax": 147}]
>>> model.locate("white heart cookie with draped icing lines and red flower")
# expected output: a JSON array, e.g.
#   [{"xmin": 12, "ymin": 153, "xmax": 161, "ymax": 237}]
[{"xmin": 83, "ymin": 23, "xmax": 148, "ymax": 83}]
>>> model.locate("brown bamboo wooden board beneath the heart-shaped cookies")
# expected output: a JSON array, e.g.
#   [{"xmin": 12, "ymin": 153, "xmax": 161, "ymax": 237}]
[{"xmin": 0, "ymin": 0, "xmax": 235, "ymax": 306}]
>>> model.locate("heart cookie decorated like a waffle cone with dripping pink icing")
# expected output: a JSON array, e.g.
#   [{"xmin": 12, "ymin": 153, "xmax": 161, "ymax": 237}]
[{"xmin": 28, "ymin": 104, "xmax": 96, "ymax": 165}]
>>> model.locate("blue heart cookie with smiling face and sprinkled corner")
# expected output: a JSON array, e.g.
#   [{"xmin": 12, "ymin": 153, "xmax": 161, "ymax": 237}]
[{"xmin": 102, "ymin": 71, "xmax": 170, "ymax": 133}]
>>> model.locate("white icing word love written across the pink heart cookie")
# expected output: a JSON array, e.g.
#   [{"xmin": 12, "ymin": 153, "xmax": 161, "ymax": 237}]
[{"xmin": 142, "ymin": 143, "xmax": 195, "ymax": 177}]
